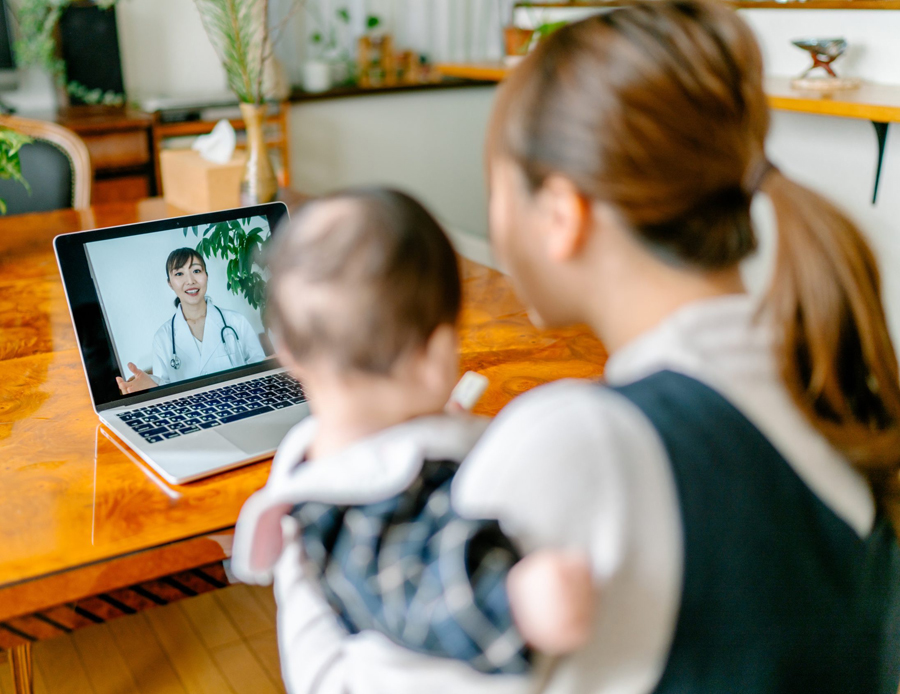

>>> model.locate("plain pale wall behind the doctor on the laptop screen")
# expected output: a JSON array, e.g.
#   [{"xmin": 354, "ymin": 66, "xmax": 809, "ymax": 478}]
[{"xmin": 87, "ymin": 217, "xmax": 268, "ymax": 376}]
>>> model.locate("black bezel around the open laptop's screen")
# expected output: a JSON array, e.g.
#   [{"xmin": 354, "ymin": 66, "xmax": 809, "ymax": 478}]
[{"xmin": 53, "ymin": 202, "xmax": 288, "ymax": 413}]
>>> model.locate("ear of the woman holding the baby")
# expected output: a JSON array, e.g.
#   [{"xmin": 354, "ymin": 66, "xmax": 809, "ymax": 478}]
[{"xmin": 538, "ymin": 174, "xmax": 591, "ymax": 262}]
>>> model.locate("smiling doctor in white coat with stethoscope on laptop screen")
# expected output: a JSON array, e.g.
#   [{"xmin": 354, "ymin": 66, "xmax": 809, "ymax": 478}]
[{"xmin": 116, "ymin": 248, "xmax": 265, "ymax": 394}]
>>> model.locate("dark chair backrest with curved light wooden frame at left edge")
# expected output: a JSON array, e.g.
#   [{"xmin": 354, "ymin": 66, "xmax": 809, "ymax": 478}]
[{"xmin": 0, "ymin": 116, "xmax": 93, "ymax": 214}]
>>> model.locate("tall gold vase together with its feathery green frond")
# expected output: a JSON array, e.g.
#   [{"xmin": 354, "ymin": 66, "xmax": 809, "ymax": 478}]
[{"xmin": 194, "ymin": 0, "xmax": 302, "ymax": 205}]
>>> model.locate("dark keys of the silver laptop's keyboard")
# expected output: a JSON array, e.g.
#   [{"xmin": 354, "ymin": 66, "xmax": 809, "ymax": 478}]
[{"xmin": 119, "ymin": 373, "xmax": 306, "ymax": 443}]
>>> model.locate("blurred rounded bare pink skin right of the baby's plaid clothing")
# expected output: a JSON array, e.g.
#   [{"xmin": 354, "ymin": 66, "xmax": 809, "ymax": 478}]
[{"xmin": 506, "ymin": 549, "xmax": 595, "ymax": 655}]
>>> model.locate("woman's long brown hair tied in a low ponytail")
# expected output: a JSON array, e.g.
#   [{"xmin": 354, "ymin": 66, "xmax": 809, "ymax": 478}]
[{"xmin": 488, "ymin": 0, "xmax": 900, "ymax": 525}]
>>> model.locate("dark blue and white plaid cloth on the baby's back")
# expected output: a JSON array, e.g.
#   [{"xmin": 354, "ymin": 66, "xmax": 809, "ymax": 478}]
[{"xmin": 292, "ymin": 460, "xmax": 530, "ymax": 674}]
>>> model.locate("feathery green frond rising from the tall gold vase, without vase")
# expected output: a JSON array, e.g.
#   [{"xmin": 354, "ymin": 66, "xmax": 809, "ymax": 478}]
[{"xmin": 194, "ymin": 0, "xmax": 268, "ymax": 103}]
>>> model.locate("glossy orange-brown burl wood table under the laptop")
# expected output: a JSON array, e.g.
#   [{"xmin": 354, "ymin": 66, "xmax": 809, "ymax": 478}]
[{"xmin": 0, "ymin": 199, "xmax": 606, "ymax": 691}]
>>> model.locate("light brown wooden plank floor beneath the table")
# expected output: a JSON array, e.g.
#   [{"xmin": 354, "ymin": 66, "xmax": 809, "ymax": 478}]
[{"xmin": 0, "ymin": 585, "xmax": 284, "ymax": 694}]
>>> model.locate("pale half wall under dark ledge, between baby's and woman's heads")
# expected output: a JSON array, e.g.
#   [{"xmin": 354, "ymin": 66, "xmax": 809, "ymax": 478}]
[{"xmin": 290, "ymin": 87, "xmax": 496, "ymax": 242}]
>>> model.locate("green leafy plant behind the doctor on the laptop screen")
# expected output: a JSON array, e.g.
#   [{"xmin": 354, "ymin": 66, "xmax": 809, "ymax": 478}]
[{"xmin": 184, "ymin": 219, "xmax": 269, "ymax": 309}]
